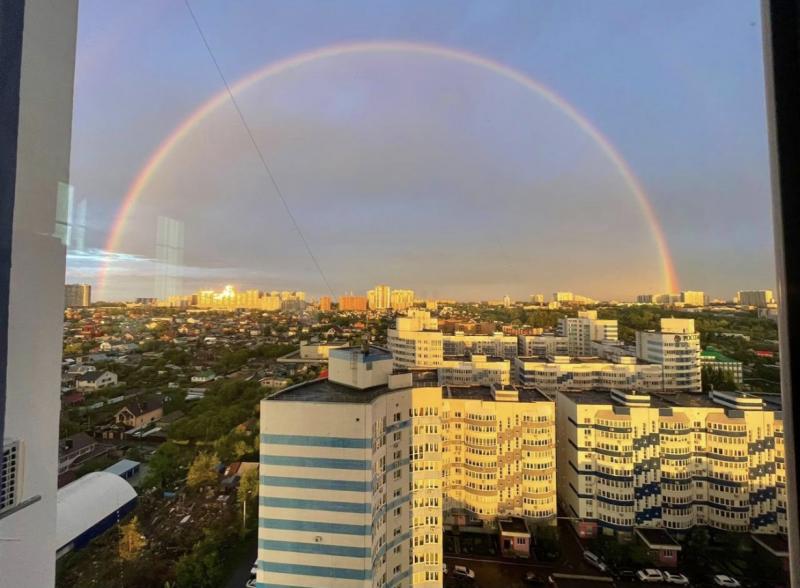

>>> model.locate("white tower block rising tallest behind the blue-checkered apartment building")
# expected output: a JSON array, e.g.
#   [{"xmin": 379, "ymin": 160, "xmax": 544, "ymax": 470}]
[{"xmin": 636, "ymin": 318, "xmax": 702, "ymax": 392}]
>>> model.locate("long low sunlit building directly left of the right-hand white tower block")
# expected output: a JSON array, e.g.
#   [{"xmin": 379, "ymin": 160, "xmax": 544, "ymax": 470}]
[{"xmin": 514, "ymin": 355, "xmax": 664, "ymax": 394}]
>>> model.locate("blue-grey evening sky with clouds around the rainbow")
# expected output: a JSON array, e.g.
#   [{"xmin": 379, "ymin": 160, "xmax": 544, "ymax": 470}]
[{"xmin": 67, "ymin": 0, "xmax": 774, "ymax": 299}]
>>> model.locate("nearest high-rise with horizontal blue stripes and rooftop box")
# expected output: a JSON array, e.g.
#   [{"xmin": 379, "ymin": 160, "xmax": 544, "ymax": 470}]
[{"xmin": 258, "ymin": 348, "xmax": 443, "ymax": 588}]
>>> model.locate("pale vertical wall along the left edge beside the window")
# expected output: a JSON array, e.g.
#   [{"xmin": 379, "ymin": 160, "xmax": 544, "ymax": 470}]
[{"xmin": 0, "ymin": 0, "xmax": 78, "ymax": 588}]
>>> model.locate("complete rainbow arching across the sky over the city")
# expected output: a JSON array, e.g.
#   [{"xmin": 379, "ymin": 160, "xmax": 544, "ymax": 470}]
[{"xmin": 98, "ymin": 41, "xmax": 680, "ymax": 293}]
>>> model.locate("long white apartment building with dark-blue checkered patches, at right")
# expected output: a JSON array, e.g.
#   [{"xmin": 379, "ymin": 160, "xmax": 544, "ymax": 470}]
[{"xmin": 557, "ymin": 390, "xmax": 786, "ymax": 536}]
